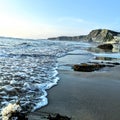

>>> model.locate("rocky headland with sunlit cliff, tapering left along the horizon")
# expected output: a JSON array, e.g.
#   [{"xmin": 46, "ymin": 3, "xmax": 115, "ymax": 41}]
[{"xmin": 48, "ymin": 29, "xmax": 120, "ymax": 43}]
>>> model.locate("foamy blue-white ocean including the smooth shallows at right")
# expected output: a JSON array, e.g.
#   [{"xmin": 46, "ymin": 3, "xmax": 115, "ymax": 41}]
[{"xmin": 0, "ymin": 38, "xmax": 120, "ymax": 117}]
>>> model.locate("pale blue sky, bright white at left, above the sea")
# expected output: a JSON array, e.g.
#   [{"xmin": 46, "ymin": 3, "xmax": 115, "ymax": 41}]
[{"xmin": 0, "ymin": 0, "xmax": 120, "ymax": 39}]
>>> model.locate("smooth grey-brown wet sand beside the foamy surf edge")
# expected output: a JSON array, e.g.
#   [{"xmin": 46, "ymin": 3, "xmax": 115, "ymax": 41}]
[{"xmin": 29, "ymin": 66, "xmax": 120, "ymax": 120}]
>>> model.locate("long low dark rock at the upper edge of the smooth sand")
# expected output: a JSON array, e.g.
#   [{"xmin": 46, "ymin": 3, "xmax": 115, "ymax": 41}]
[{"xmin": 73, "ymin": 63, "xmax": 105, "ymax": 72}]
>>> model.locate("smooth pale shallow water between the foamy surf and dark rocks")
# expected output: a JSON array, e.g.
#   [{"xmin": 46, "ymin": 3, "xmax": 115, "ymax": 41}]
[{"xmin": 58, "ymin": 43, "xmax": 120, "ymax": 70}]
